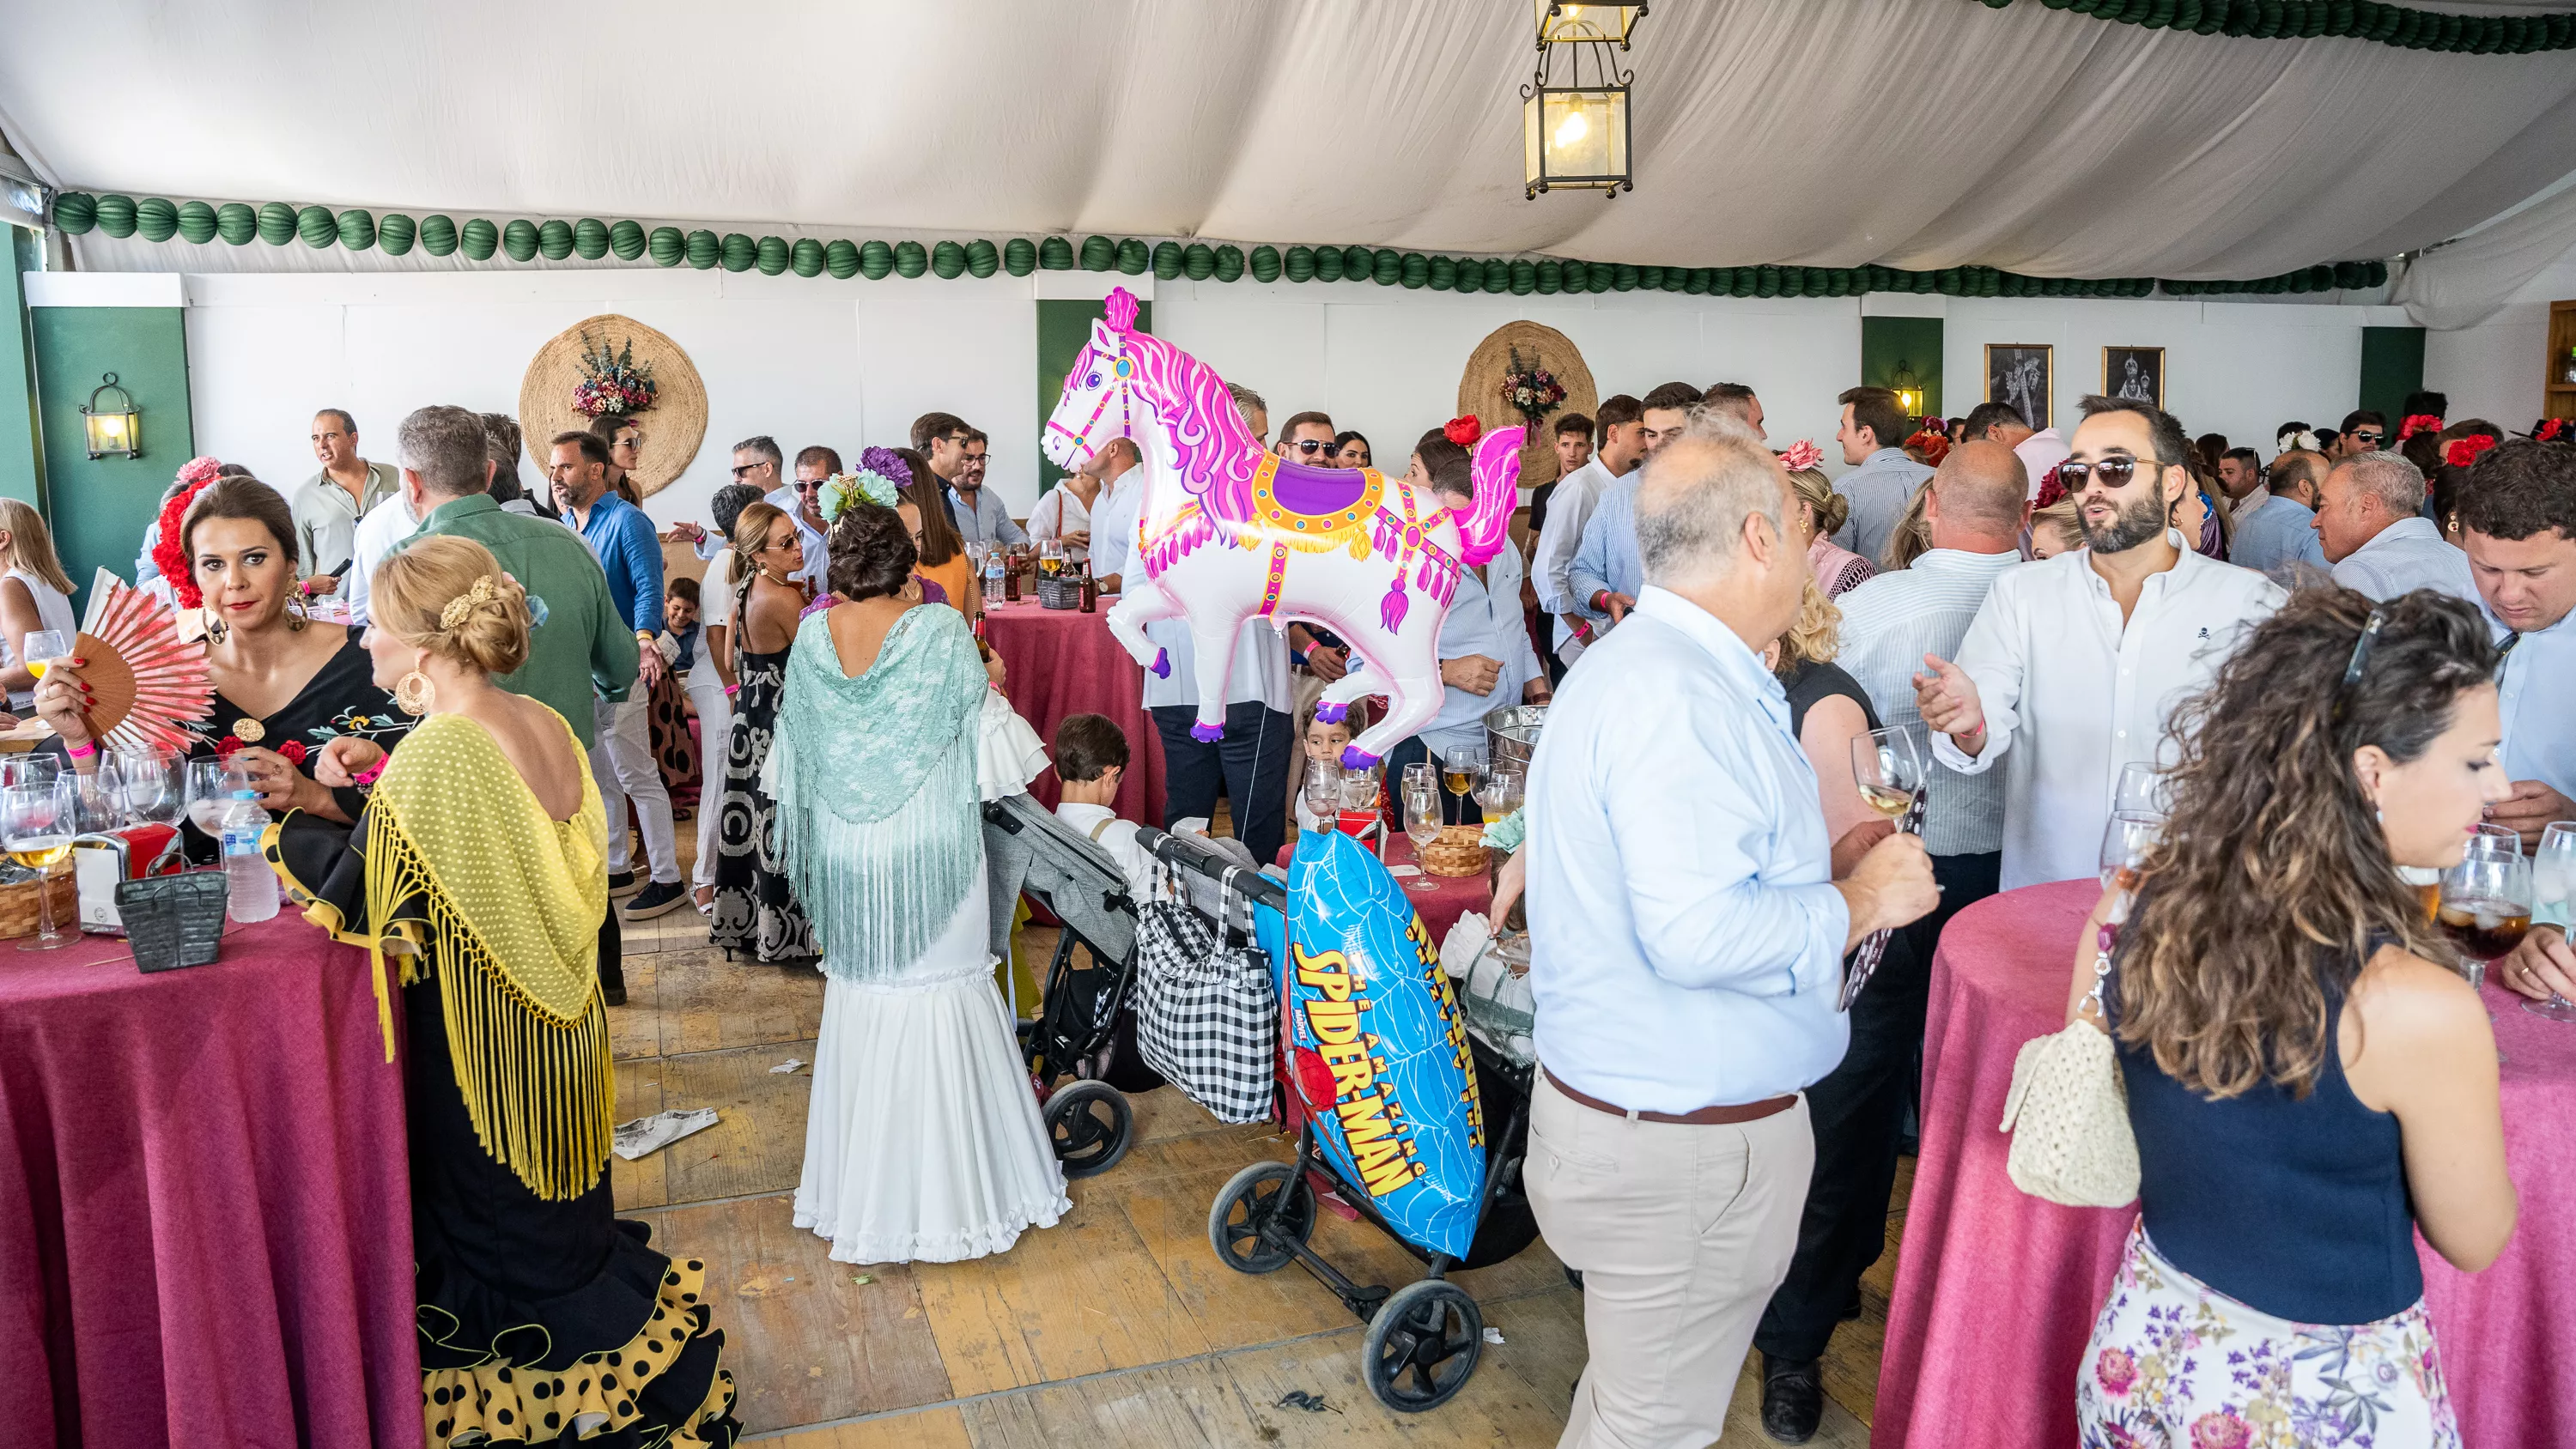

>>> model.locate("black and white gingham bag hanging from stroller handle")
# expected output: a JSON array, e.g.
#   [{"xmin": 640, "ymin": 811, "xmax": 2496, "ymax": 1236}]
[{"xmin": 1136, "ymin": 870, "xmax": 1280, "ymax": 1122}]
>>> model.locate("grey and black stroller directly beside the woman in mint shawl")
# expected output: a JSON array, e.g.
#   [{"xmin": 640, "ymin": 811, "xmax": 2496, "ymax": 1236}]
[{"xmin": 984, "ymin": 795, "xmax": 1162, "ymax": 1176}]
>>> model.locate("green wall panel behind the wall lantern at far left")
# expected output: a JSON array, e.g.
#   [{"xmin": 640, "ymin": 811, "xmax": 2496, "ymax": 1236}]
[{"xmin": 28, "ymin": 306, "xmax": 196, "ymax": 608}]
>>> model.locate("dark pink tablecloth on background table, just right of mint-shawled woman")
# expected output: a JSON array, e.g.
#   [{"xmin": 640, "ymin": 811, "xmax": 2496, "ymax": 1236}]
[{"xmin": 984, "ymin": 600, "xmax": 1162, "ymax": 826}]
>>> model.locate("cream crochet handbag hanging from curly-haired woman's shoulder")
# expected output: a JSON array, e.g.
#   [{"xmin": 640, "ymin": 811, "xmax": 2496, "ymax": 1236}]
[{"xmin": 2002, "ymin": 924, "xmax": 2138, "ymax": 1207}]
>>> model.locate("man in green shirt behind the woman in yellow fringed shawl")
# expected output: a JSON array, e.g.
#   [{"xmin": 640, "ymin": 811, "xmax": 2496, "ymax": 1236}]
[{"xmin": 399, "ymin": 407, "xmax": 639, "ymax": 1006}]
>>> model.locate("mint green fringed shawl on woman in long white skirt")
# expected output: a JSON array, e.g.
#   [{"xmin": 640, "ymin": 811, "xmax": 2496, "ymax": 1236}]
[{"xmin": 770, "ymin": 605, "xmax": 987, "ymax": 983}]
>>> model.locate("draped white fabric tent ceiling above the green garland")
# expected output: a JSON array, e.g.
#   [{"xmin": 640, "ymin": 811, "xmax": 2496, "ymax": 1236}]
[{"xmin": 0, "ymin": 0, "xmax": 2576, "ymax": 292}]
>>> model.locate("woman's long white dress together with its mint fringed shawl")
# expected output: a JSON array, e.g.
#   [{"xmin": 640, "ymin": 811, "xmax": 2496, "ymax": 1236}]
[{"xmin": 770, "ymin": 608, "xmax": 1072, "ymax": 1264}]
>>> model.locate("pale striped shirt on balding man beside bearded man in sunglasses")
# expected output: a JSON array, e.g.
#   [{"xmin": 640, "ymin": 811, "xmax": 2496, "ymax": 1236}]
[{"xmin": 1834, "ymin": 549, "xmax": 2022, "ymax": 854}]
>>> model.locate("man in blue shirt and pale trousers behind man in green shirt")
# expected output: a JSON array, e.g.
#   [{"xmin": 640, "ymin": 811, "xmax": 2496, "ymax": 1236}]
[{"xmin": 549, "ymin": 433, "xmax": 688, "ymax": 921}]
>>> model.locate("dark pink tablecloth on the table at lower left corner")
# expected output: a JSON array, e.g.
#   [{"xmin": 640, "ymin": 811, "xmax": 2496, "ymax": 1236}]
[{"xmin": 0, "ymin": 913, "xmax": 420, "ymax": 1449}]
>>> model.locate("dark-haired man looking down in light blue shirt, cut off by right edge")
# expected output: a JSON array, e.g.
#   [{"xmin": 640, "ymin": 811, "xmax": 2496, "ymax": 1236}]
[{"xmin": 2460, "ymin": 438, "xmax": 2576, "ymax": 846}]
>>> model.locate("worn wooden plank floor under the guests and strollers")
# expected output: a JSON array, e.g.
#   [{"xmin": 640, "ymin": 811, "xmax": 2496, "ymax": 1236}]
[{"xmin": 608, "ymin": 823, "xmax": 1911, "ymax": 1449}]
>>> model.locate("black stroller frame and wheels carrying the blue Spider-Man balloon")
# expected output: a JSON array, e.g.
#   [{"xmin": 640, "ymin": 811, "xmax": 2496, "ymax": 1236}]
[{"xmin": 1136, "ymin": 828, "xmax": 1538, "ymax": 1413}]
